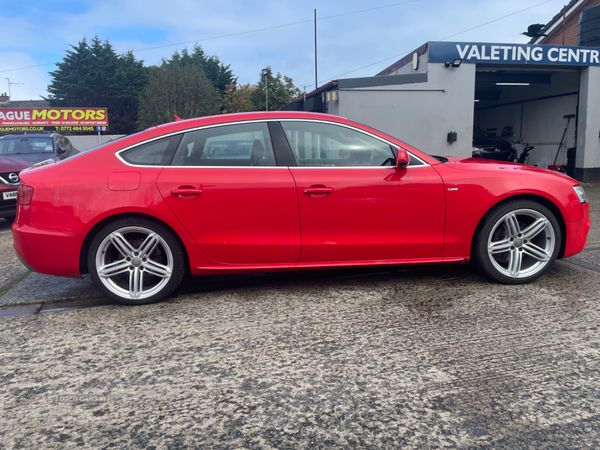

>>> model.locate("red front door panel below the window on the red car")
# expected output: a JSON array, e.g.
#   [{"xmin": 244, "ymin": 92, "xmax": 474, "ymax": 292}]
[{"xmin": 290, "ymin": 166, "xmax": 444, "ymax": 263}]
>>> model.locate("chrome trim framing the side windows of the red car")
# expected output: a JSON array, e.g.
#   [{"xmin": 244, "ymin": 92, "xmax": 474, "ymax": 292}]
[{"xmin": 115, "ymin": 118, "xmax": 430, "ymax": 169}]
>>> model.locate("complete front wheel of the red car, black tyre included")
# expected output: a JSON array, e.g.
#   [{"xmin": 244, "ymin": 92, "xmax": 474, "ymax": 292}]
[{"xmin": 473, "ymin": 200, "xmax": 562, "ymax": 284}]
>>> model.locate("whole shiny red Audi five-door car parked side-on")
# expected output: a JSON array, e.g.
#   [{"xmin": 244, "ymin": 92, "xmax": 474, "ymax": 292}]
[{"xmin": 13, "ymin": 112, "xmax": 590, "ymax": 304}]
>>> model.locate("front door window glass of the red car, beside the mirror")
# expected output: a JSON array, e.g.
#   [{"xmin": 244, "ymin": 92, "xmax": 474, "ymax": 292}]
[{"xmin": 281, "ymin": 121, "xmax": 396, "ymax": 167}]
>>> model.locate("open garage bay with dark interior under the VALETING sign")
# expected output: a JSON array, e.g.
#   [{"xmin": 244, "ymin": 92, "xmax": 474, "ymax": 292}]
[{"xmin": 473, "ymin": 64, "xmax": 580, "ymax": 176}]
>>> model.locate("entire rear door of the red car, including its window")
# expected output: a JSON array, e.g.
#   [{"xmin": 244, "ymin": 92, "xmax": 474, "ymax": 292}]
[{"xmin": 157, "ymin": 122, "xmax": 300, "ymax": 264}]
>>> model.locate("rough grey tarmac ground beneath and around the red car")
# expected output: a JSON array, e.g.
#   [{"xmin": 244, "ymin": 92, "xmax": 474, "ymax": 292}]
[{"xmin": 0, "ymin": 184, "xmax": 600, "ymax": 449}]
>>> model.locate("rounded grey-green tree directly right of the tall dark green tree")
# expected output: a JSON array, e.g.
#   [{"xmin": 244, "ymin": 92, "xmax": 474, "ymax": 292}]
[{"xmin": 139, "ymin": 64, "xmax": 221, "ymax": 129}]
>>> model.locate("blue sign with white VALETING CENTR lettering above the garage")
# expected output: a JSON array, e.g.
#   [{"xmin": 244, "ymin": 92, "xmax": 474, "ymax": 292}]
[{"xmin": 429, "ymin": 42, "xmax": 600, "ymax": 66}]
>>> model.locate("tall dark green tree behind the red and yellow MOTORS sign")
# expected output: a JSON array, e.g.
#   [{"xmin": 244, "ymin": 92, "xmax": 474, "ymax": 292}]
[{"xmin": 47, "ymin": 36, "xmax": 148, "ymax": 134}]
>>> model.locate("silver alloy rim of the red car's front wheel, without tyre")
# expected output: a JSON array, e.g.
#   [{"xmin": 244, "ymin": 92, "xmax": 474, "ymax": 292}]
[{"xmin": 487, "ymin": 209, "xmax": 556, "ymax": 278}]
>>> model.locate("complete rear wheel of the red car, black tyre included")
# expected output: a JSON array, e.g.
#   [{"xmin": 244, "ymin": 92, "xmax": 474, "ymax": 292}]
[{"xmin": 87, "ymin": 218, "xmax": 186, "ymax": 305}]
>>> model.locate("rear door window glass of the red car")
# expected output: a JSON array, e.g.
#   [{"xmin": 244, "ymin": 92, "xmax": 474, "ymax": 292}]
[{"xmin": 171, "ymin": 123, "xmax": 276, "ymax": 166}]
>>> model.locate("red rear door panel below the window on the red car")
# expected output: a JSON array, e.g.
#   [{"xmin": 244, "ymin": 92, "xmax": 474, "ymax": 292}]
[{"xmin": 157, "ymin": 167, "xmax": 300, "ymax": 264}]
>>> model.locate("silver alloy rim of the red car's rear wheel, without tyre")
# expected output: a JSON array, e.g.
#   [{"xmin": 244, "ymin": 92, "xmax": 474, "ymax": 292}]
[{"xmin": 95, "ymin": 226, "xmax": 173, "ymax": 300}]
